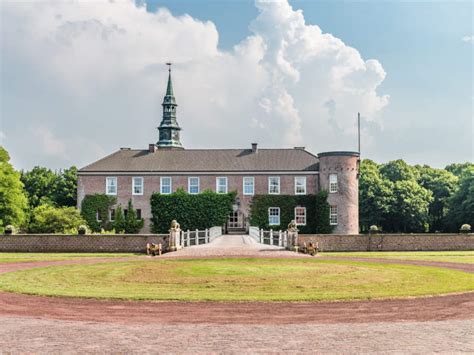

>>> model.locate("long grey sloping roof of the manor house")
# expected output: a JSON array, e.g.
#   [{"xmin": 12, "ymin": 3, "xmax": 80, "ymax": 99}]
[{"xmin": 79, "ymin": 148, "xmax": 318, "ymax": 173}]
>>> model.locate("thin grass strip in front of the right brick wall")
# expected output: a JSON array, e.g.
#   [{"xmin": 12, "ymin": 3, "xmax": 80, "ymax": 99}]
[{"xmin": 321, "ymin": 251, "xmax": 474, "ymax": 264}]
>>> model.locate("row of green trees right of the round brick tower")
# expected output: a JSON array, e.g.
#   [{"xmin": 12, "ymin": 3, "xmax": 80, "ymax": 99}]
[{"xmin": 359, "ymin": 159, "xmax": 474, "ymax": 233}]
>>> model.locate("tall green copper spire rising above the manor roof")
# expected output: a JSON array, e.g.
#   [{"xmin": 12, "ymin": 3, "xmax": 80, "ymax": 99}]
[{"xmin": 156, "ymin": 63, "xmax": 183, "ymax": 149}]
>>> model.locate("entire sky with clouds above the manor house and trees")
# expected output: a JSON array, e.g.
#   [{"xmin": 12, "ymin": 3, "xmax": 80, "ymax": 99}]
[{"xmin": 0, "ymin": 0, "xmax": 474, "ymax": 169}]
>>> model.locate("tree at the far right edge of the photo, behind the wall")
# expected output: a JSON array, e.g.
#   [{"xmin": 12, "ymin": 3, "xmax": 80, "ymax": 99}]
[{"xmin": 446, "ymin": 164, "xmax": 474, "ymax": 232}]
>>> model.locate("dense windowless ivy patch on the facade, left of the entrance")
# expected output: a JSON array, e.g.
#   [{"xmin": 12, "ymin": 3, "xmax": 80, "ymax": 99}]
[{"xmin": 150, "ymin": 189, "xmax": 236, "ymax": 233}]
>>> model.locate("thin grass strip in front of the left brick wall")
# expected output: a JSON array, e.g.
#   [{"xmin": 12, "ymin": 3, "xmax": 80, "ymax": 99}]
[{"xmin": 0, "ymin": 253, "xmax": 135, "ymax": 263}]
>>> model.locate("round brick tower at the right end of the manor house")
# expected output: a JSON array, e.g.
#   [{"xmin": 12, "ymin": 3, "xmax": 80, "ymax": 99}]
[{"xmin": 318, "ymin": 152, "xmax": 359, "ymax": 234}]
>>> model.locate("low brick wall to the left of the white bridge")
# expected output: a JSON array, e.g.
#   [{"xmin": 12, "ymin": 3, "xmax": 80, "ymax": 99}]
[{"xmin": 0, "ymin": 234, "xmax": 169, "ymax": 253}]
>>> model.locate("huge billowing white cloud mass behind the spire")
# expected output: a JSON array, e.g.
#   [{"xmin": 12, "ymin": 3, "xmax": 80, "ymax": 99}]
[{"xmin": 0, "ymin": 1, "xmax": 388, "ymax": 167}]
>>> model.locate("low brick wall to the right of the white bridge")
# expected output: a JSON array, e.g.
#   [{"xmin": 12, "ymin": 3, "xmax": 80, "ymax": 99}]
[{"xmin": 298, "ymin": 234, "xmax": 474, "ymax": 251}]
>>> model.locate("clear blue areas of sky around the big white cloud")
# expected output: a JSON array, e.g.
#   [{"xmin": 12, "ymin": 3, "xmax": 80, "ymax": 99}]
[{"xmin": 147, "ymin": 0, "xmax": 474, "ymax": 167}]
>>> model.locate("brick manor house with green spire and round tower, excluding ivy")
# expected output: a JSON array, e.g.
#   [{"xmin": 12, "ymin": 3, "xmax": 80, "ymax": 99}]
[{"xmin": 78, "ymin": 70, "xmax": 359, "ymax": 234}]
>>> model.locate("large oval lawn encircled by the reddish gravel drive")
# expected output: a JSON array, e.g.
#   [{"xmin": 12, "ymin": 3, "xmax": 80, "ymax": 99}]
[{"xmin": 0, "ymin": 259, "xmax": 474, "ymax": 301}]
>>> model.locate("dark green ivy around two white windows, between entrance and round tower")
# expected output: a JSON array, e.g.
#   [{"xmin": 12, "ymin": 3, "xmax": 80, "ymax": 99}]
[{"xmin": 250, "ymin": 191, "xmax": 332, "ymax": 233}]
